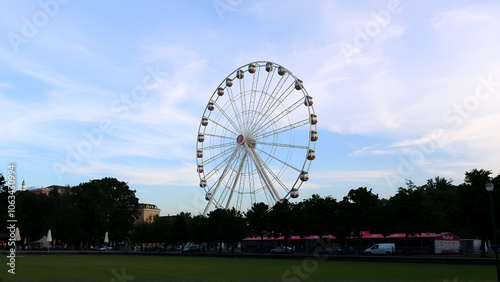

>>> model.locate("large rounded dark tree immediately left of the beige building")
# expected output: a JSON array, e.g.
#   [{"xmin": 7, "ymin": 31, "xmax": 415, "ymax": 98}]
[{"xmin": 73, "ymin": 177, "xmax": 138, "ymax": 247}]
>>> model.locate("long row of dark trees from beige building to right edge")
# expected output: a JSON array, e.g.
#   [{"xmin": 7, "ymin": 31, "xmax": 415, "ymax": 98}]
[{"xmin": 131, "ymin": 169, "xmax": 500, "ymax": 255}]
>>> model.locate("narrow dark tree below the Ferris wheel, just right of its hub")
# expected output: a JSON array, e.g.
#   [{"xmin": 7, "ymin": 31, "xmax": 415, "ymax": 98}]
[{"xmin": 246, "ymin": 203, "xmax": 270, "ymax": 253}]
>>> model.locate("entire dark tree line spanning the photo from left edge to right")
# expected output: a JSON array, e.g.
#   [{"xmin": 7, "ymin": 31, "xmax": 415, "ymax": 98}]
[{"xmin": 0, "ymin": 169, "xmax": 500, "ymax": 254}]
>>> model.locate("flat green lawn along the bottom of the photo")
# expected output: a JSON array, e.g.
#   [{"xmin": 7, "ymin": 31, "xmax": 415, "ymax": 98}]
[{"xmin": 0, "ymin": 255, "xmax": 496, "ymax": 281}]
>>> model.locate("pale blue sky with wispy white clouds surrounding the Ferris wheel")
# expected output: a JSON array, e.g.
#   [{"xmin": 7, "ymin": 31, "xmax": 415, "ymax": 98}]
[{"xmin": 0, "ymin": 0, "xmax": 500, "ymax": 215}]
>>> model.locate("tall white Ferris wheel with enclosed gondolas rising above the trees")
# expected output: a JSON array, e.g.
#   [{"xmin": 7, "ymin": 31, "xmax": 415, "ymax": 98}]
[{"xmin": 196, "ymin": 61, "xmax": 318, "ymax": 214}]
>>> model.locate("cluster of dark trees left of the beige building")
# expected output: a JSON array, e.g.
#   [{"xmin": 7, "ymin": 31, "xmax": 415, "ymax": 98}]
[{"xmin": 0, "ymin": 177, "xmax": 139, "ymax": 247}]
